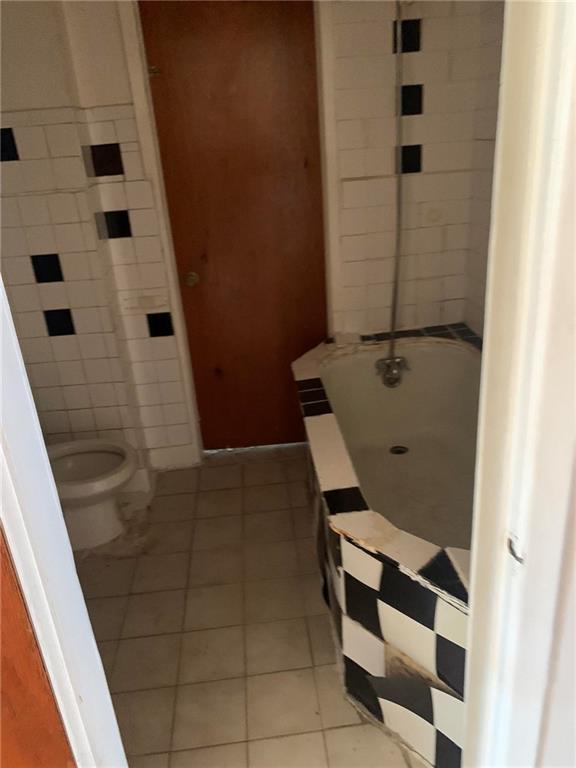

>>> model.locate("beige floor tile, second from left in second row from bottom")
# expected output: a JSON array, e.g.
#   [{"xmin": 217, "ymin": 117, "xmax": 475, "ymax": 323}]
[{"xmin": 172, "ymin": 679, "xmax": 246, "ymax": 749}]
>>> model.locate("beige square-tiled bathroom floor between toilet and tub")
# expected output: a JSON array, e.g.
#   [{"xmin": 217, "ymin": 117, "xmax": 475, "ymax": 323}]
[{"xmin": 78, "ymin": 446, "xmax": 407, "ymax": 768}]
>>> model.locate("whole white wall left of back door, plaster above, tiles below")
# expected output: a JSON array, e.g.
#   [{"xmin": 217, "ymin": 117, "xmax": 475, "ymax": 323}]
[{"xmin": 1, "ymin": 2, "xmax": 200, "ymax": 467}]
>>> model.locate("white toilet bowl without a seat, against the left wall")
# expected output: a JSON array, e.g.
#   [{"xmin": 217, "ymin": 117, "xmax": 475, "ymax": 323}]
[{"xmin": 48, "ymin": 440, "xmax": 137, "ymax": 550}]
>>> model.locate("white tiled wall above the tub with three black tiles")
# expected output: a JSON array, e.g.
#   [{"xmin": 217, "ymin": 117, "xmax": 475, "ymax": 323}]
[{"xmin": 323, "ymin": 2, "xmax": 502, "ymax": 333}]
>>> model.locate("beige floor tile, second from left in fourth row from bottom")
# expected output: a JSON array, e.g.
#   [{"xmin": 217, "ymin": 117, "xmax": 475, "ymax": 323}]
[{"xmin": 122, "ymin": 590, "xmax": 185, "ymax": 637}]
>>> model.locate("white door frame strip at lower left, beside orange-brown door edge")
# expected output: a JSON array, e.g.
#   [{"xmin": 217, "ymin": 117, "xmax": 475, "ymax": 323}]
[{"xmin": 0, "ymin": 282, "xmax": 127, "ymax": 768}]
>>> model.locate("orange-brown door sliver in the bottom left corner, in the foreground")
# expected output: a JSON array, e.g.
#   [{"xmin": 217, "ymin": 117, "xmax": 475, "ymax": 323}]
[{"xmin": 0, "ymin": 531, "xmax": 76, "ymax": 768}]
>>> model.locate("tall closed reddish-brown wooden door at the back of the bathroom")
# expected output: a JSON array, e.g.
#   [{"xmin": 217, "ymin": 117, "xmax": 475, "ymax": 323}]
[{"xmin": 140, "ymin": 0, "xmax": 326, "ymax": 448}]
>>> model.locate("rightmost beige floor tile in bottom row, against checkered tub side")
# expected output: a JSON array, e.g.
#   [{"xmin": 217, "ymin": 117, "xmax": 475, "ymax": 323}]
[{"xmin": 324, "ymin": 725, "xmax": 406, "ymax": 768}]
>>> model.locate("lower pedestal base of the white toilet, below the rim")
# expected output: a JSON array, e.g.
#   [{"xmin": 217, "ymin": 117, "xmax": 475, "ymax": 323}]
[{"xmin": 63, "ymin": 496, "xmax": 124, "ymax": 552}]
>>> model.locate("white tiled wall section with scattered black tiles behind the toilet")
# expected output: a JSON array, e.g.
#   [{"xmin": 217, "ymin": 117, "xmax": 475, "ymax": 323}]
[{"xmin": 1, "ymin": 104, "xmax": 192, "ymax": 466}]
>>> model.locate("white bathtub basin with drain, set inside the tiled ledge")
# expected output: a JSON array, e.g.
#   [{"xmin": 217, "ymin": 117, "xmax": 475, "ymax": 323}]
[{"xmin": 319, "ymin": 338, "xmax": 480, "ymax": 549}]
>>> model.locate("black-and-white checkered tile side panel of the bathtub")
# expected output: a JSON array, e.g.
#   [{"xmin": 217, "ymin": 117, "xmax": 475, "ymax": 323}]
[{"xmin": 325, "ymin": 520, "xmax": 467, "ymax": 768}]
